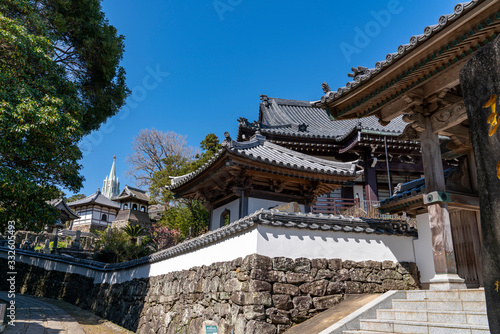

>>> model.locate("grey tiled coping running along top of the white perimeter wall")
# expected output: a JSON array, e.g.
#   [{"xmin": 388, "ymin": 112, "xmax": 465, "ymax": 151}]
[{"xmin": 0, "ymin": 209, "xmax": 418, "ymax": 271}]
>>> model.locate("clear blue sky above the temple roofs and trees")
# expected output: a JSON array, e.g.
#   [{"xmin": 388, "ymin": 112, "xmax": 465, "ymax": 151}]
[{"xmin": 68, "ymin": 0, "xmax": 457, "ymax": 195}]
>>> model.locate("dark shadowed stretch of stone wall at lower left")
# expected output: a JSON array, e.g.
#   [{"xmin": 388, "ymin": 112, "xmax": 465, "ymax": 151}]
[{"xmin": 0, "ymin": 258, "xmax": 150, "ymax": 332}]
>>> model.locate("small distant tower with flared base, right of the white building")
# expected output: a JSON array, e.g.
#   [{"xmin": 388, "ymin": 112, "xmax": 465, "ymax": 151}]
[{"xmin": 113, "ymin": 186, "xmax": 151, "ymax": 227}]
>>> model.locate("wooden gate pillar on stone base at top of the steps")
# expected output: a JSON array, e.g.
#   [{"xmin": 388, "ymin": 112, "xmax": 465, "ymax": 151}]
[{"xmin": 420, "ymin": 117, "xmax": 465, "ymax": 290}]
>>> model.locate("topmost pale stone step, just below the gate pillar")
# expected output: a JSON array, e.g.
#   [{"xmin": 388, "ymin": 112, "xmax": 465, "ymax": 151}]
[{"xmin": 406, "ymin": 289, "xmax": 486, "ymax": 302}]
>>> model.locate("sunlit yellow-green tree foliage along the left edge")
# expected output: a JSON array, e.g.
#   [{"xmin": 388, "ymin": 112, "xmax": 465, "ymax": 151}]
[{"xmin": 0, "ymin": 9, "xmax": 83, "ymax": 229}]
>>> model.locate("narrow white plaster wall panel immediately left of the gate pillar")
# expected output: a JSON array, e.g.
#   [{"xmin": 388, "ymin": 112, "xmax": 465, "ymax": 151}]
[{"xmin": 414, "ymin": 213, "xmax": 436, "ymax": 283}]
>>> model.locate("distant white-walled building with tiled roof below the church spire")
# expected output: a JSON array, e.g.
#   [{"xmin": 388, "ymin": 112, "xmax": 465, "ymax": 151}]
[{"xmin": 68, "ymin": 190, "xmax": 120, "ymax": 232}]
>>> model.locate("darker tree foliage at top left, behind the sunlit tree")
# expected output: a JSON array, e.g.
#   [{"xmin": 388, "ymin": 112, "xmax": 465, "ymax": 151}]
[{"xmin": 0, "ymin": 0, "xmax": 129, "ymax": 134}]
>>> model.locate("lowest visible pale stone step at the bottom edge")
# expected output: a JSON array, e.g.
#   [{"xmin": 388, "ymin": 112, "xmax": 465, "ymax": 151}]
[{"xmin": 358, "ymin": 319, "xmax": 489, "ymax": 334}]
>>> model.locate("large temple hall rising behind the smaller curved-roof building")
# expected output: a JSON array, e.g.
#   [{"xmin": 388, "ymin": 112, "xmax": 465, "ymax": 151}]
[{"xmin": 238, "ymin": 95, "xmax": 430, "ymax": 212}]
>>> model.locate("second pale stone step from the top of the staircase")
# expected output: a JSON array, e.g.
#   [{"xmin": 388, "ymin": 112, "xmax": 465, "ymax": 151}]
[{"xmin": 392, "ymin": 299, "xmax": 486, "ymax": 312}]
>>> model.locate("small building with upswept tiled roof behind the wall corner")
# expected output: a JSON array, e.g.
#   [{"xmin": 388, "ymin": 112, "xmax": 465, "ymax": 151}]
[{"xmin": 169, "ymin": 132, "xmax": 363, "ymax": 230}]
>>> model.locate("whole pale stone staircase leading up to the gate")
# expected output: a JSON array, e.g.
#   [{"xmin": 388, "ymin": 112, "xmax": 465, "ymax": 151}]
[{"xmin": 342, "ymin": 289, "xmax": 490, "ymax": 334}]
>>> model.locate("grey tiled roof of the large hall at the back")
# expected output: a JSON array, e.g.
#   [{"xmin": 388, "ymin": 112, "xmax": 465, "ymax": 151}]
[{"xmin": 240, "ymin": 95, "xmax": 407, "ymax": 141}]
